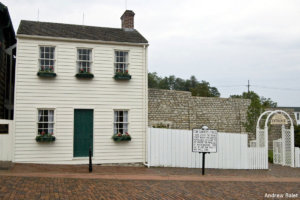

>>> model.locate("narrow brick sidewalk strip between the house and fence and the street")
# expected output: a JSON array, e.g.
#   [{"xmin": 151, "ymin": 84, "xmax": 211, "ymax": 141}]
[{"xmin": 0, "ymin": 164, "xmax": 300, "ymax": 178}]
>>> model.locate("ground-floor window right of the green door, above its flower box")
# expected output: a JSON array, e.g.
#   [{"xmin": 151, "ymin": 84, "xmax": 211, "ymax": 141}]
[{"xmin": 114, "ymin": 110, "xmax": 128, "ymax": 134}]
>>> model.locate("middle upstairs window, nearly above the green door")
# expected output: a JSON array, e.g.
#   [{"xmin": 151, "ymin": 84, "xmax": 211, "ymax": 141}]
[{"xmin": 77, "ymin": 49, "xmax": 92, "ymax": 73}]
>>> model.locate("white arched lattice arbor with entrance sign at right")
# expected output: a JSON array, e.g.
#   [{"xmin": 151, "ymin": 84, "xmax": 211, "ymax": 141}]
[{"xmin": 250, "ymin": 110, "xmax": 295, "ymax": 167}]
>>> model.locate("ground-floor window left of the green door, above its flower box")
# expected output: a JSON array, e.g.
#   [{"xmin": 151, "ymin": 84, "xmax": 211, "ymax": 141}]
[{"xmin": 38, "ymin": 109, "xmax": 54, "ymax": 135}]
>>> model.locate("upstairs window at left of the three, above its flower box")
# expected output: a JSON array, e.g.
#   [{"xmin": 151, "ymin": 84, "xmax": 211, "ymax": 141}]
[{"xmin": 39, "ymin": 46, "xmax": 55, "ymax": 72}]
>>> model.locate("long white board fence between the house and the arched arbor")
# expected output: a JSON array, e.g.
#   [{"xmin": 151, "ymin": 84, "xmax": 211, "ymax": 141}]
[{"xmin": 147, "ymin": 128, "xmax": 268, "ymax": 169}]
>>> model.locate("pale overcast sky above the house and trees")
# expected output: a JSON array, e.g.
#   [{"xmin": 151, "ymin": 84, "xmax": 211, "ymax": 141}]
[{"xmin": 2, "ymin": 0, "xmax": 300, "ymax": 107}]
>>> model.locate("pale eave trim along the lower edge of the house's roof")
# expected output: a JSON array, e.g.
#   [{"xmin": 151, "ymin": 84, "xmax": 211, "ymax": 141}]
[{"xmin": 16, "ymin": 34, "xmax": 149, "ymax": 46}]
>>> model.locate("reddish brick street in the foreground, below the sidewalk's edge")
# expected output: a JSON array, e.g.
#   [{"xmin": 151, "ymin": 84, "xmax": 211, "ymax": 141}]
[{"xmin": 0, "ymin": 176, "xmax": 300, "ymax": 200}]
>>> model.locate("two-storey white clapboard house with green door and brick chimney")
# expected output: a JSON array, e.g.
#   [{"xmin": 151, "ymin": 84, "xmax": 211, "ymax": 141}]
[{"xmin": 13, "ymin": 10, "xmax": 148, "ymax": 164}]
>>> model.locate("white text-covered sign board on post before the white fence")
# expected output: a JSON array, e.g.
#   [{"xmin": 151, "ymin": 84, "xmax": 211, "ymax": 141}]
[{"xmin": 192, "ymin": 129, "xmax": 218, "ymax": 153}]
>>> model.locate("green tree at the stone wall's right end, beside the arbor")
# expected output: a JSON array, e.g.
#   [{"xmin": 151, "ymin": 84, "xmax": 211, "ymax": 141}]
[{"xmin": 230, "ymin": 91, "xmax": 277, "ymax": 133}]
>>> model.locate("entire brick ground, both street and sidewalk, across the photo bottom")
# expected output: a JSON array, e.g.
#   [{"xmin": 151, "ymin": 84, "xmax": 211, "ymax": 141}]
[{"xmin": 0, "ymin": 165, "xmax": 300, "ymax": 200}]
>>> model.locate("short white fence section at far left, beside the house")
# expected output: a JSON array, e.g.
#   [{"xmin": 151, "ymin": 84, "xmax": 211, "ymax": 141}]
[{"xmin": 0, "ymin": 119, "xmax": 14, "ymax": 161}]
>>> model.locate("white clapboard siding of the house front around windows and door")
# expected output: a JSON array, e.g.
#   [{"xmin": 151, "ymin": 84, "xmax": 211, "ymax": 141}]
[{"xmin": 14, "ymin": 38, "xmax": 147, "ymax": 164}]
